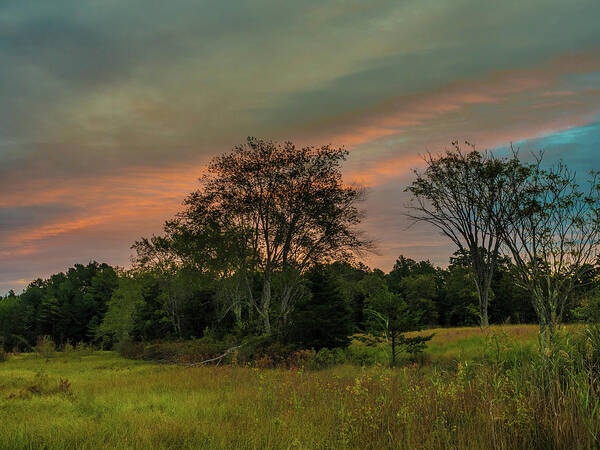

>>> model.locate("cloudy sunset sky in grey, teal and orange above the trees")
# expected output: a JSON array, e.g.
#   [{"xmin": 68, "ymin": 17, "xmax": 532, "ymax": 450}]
[{"xmin": 0, "ymin": 0, "xmax": 600, "ymax": 294}]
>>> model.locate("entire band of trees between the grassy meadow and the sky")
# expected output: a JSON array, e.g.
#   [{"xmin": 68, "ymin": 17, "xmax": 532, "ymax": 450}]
[{"xmin": 0, "ymin": 138, "xmax": 600, "ymax": 357}]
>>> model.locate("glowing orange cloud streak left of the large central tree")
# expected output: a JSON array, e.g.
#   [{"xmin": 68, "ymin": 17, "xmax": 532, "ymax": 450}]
[{"xmin": 0, "ymin": 165, "xmax": 203, "ymax": 257}]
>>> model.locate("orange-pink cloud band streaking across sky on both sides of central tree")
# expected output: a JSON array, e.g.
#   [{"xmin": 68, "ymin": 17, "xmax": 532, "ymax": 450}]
[{"xmin": 0, "ymin": 51, "xmax": 600, "ymax": 282}]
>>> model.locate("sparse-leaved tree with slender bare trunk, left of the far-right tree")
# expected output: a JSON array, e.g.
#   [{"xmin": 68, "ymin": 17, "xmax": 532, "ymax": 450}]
[{"xmin": 406, "ymin": 142, "xmax": 520, "ymax": 326}]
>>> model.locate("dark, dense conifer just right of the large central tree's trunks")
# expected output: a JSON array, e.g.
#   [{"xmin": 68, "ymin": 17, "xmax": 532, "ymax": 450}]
[{"xmin": 290, "ymin": 265, "xmax": 353, "ymax": 350}]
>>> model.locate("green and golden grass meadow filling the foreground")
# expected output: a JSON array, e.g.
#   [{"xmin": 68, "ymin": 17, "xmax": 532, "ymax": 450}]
[{"xmin": 0, "ymin": 326, "xmax": 600, "ymax": 448}]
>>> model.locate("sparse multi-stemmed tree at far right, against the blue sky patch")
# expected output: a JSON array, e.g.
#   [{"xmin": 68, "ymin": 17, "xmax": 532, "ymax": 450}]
[{"xmin": 503, "ymin": 158, "xmax": 600, "ymax": 341}]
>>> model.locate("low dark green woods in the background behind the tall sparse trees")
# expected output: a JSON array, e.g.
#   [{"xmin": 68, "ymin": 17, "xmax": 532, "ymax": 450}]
[{"xmin": 0, "ymin": 253, "xmax": 548, "ymax": 351}]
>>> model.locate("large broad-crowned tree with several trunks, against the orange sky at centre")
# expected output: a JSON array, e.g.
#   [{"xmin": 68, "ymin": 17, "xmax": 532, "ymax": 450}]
[{"xmin": 143, "ymin": 138, "xmax": 370, "ymax": 333}]
